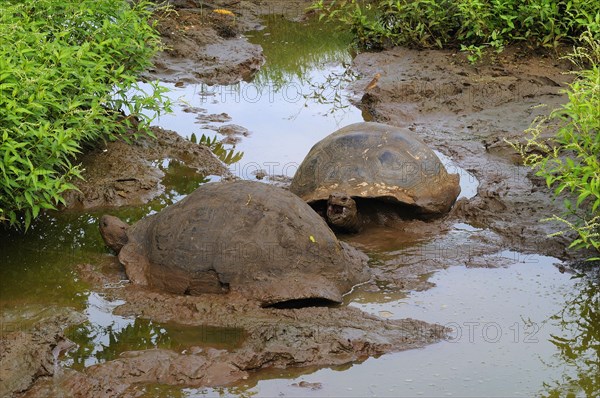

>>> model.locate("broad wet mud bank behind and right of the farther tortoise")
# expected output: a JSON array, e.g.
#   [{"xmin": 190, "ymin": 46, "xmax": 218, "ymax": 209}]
[{"xmin": 353, "ymin": 48, "xmax": 574, "ymax": 259}]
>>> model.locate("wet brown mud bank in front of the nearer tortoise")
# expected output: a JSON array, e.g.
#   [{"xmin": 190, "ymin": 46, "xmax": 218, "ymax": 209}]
[{"xmin": 22, "ymin": 264, "xmax": 446, "ymax": 397}]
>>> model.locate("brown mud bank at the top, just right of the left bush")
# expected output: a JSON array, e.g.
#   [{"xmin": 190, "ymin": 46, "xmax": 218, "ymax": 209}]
[{"xmin": 146, "ymin": 0, "xmax": 311, "ymax": 85}]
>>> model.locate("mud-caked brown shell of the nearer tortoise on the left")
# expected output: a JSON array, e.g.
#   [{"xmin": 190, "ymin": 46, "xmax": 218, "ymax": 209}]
[{"xmin": 119, "ymin": 181, "xmax": 369, "ymax": 305}]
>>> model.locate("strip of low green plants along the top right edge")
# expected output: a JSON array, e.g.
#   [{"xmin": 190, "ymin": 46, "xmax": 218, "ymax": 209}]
[{"xmin": 312, "ymin": 0, "xmax": 600, "ymax": 60}]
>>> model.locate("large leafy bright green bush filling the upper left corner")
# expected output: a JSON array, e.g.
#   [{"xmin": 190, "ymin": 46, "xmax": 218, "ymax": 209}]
[{"xmin": 0, "ymin": 0, "xmax": 169, "ymax": 228}]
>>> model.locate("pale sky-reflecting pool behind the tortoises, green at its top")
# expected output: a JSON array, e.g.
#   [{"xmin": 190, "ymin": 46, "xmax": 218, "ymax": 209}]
[{"xmin": 151, "ymin": 17, "xmax": 363, "ymax": 179}]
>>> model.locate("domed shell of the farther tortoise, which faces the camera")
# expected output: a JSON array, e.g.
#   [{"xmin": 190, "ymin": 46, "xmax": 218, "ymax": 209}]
[{"xmin": 290, "ymin": 122, "xmax": 460, "ymax": 214}]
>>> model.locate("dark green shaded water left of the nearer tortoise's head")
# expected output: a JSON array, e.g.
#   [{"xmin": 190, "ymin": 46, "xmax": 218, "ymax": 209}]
[{"xmin": 0, "ymin": 155, "xmax": 214, "ymax": 314}]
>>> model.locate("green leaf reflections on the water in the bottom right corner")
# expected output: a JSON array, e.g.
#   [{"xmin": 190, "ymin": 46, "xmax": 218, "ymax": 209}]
[{"xmin": 542, "ymin": 275, "xmax": 600, "ymax": 398}]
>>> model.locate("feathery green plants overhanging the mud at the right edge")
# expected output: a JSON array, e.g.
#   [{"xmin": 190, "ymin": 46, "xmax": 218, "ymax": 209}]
[{"xmin": 514, "ymin": 33, "xmax": 600, "ymax": 259}]
